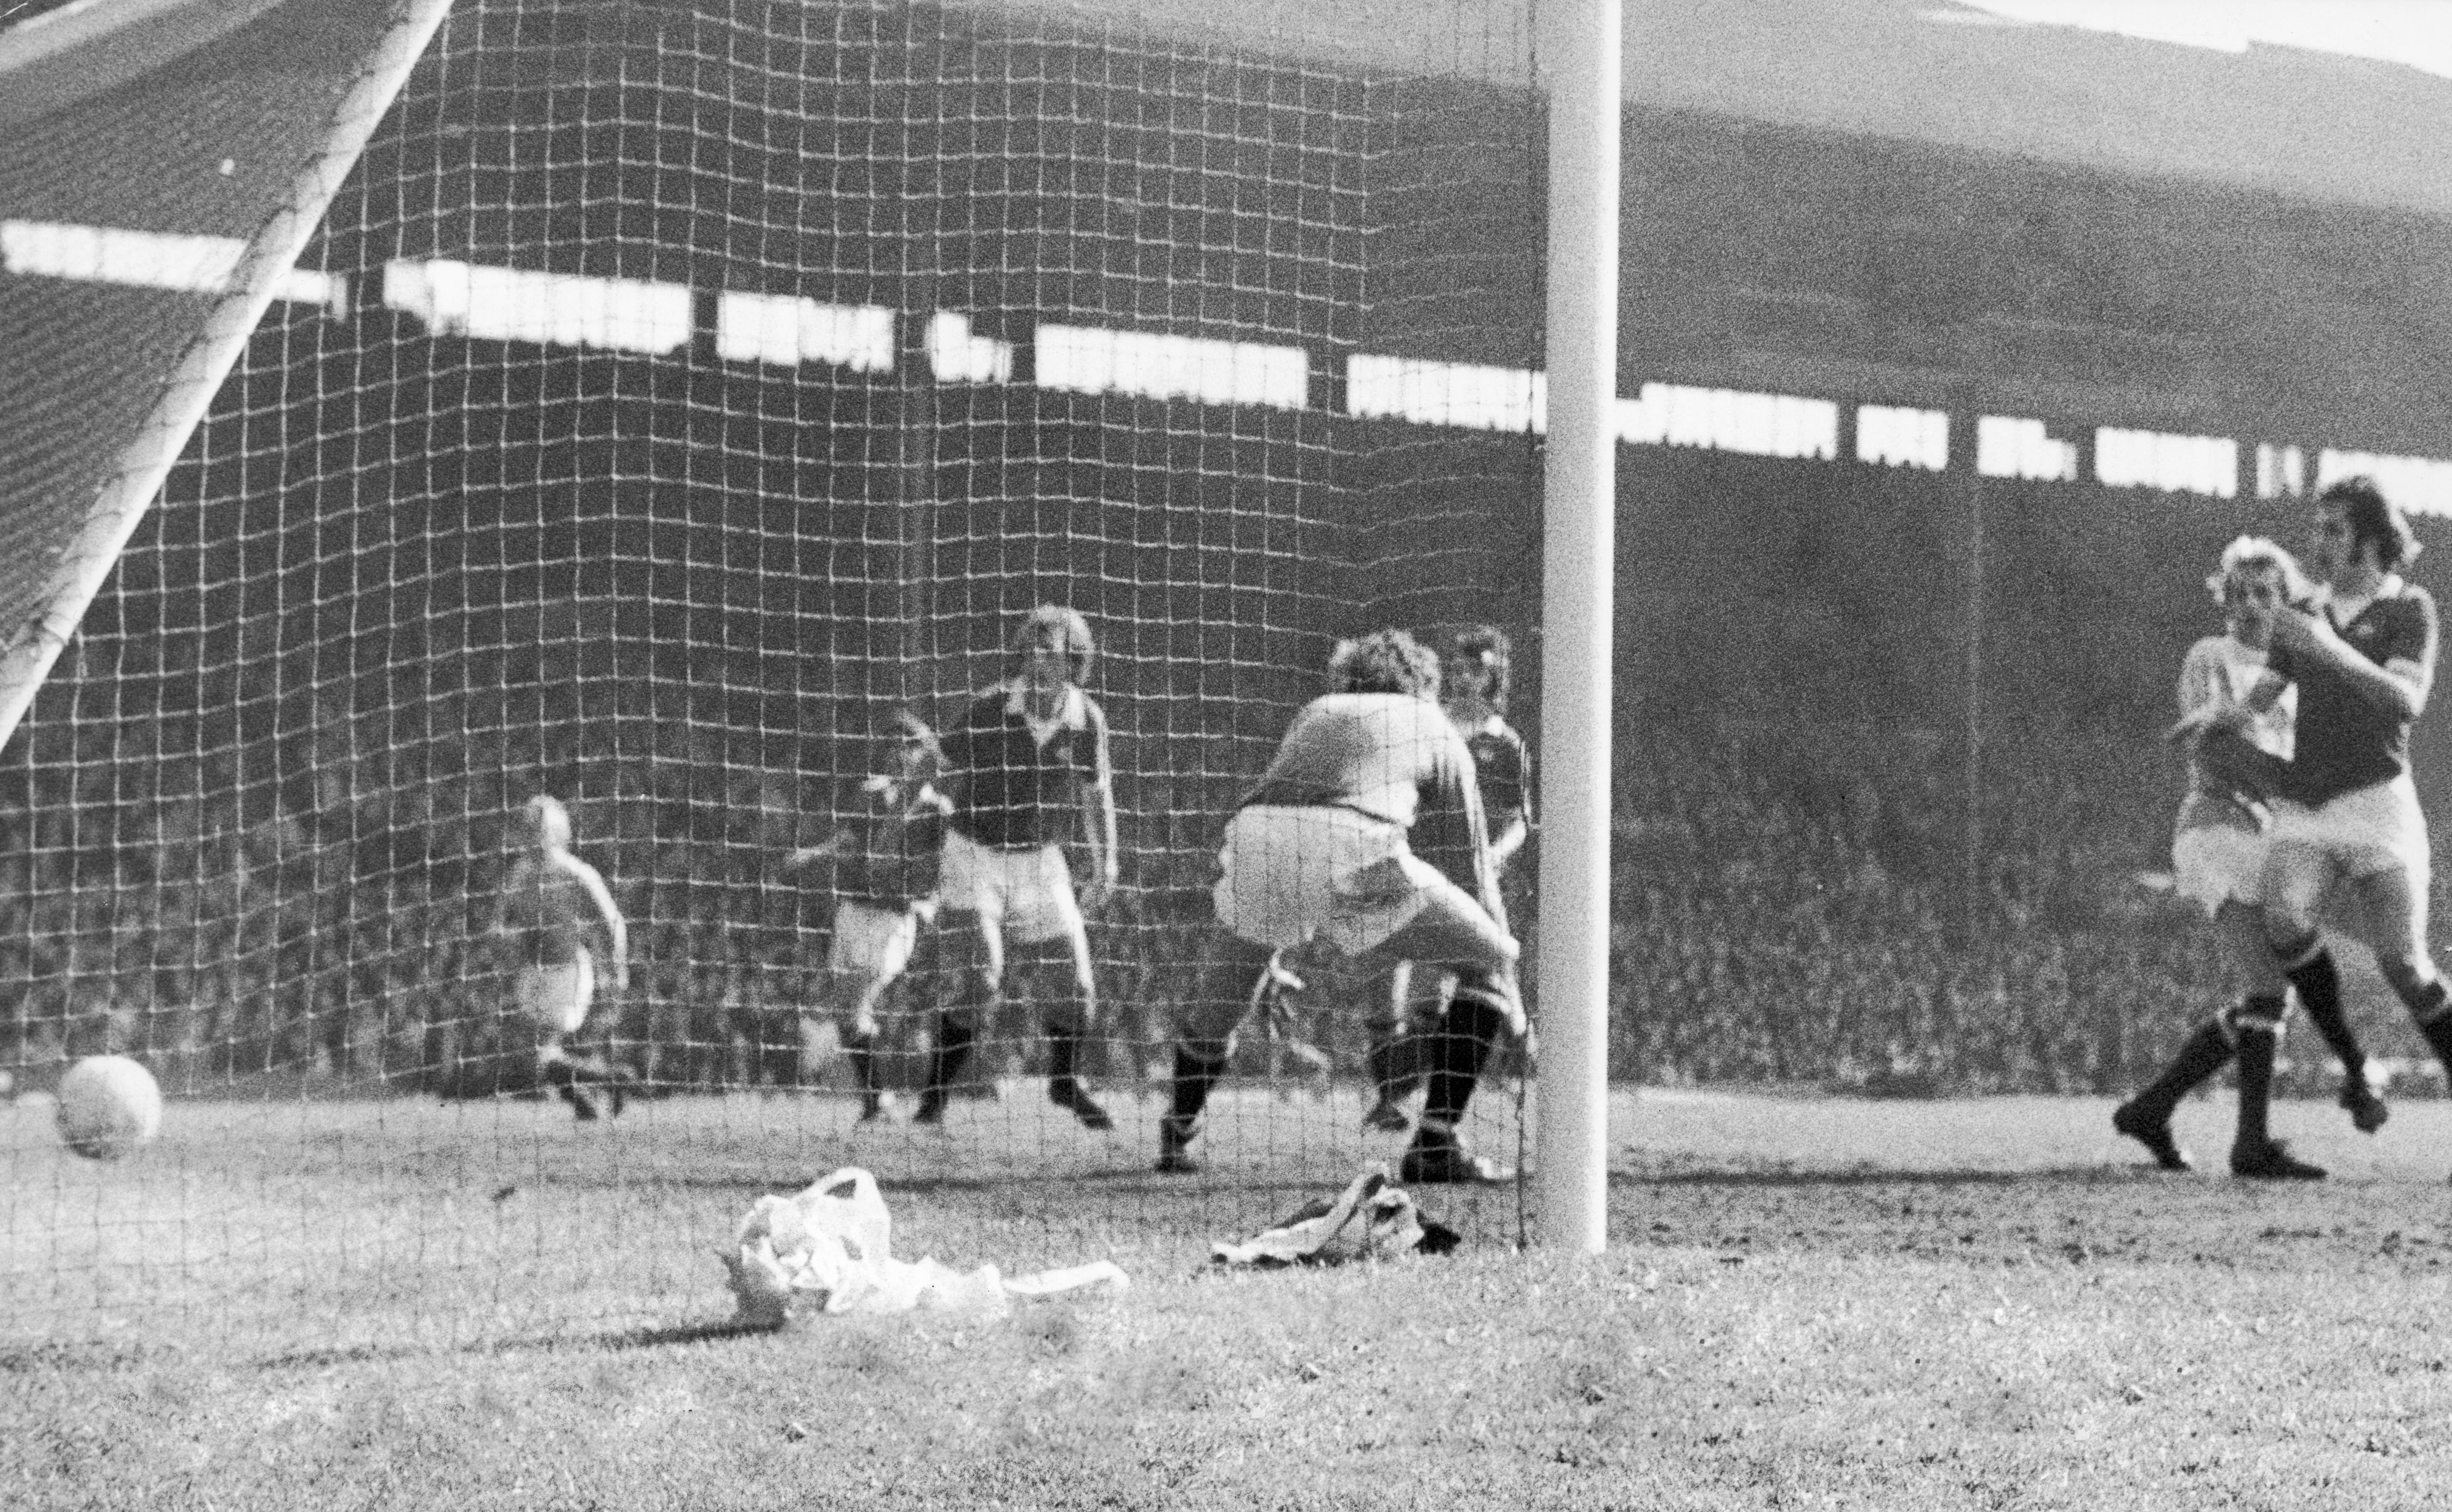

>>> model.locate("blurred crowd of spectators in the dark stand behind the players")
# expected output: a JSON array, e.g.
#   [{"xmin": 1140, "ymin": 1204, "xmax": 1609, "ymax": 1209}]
[{"xmin": 0, "ymin": 706, "xmax": 2401, "ymax": 1095}]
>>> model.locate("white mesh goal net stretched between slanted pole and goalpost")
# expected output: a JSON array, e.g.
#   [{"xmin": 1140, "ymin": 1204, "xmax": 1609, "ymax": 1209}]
[{"xmin": 0, "ymin": 0, "xmax": 1542, "ymax": 1333}]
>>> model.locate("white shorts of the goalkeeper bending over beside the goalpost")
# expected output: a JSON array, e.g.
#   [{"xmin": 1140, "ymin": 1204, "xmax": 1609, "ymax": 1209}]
[{"xmin": 1209, "ymin": 804, "xmax": 1447, "ymax": 956}]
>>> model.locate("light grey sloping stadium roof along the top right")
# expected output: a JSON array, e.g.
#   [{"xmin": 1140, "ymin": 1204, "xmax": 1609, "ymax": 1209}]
[{"xmin": 1010, "ymin": 0, "xmax": 2452, "ymax": 213}]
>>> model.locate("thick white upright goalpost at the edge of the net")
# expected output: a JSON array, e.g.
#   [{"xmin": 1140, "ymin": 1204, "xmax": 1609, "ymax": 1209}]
[{"xmin": 1533, "ymin": 0, "xmax": 1623, "ymax": 1255}]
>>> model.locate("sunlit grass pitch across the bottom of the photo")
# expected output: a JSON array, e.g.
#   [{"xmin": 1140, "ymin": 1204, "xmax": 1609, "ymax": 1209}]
[{"xmin": 0, "ymin": 1091, "xmax": 2452, "ymax": 1512}]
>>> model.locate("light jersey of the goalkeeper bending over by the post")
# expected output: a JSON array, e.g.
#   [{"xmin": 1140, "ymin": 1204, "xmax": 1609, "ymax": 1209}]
[{"xmin": 1241, "ymin": 694, "xmax": 1498, "ymax": 909}]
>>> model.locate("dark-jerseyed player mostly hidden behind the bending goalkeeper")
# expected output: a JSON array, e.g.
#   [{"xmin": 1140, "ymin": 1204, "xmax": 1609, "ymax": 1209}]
[{"xmin": 1363, "ymin": 625, "xmax": 1533, "ymax": 1132}]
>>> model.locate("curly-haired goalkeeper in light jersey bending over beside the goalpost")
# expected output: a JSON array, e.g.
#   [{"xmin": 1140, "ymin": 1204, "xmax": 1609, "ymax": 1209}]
[{"xmin": 1157, "ymin": 630, "xmax": 1525, "ymax": 1181}]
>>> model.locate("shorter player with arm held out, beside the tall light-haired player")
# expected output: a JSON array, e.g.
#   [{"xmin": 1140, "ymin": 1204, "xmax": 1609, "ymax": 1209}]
[{"xmin": 785, "ymin": 711, "xmax": 954, "ymax": 1122}]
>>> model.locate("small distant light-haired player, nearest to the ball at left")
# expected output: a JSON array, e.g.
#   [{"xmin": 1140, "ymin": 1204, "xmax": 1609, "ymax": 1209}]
[{"xmin": 495, "ymin": 794, "xmax": 638, "ymax": 1122}]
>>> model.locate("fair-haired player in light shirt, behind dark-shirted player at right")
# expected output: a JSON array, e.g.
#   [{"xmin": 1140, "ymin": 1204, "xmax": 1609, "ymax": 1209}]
[{"xmin": 2111, "ymin": 537, "xmax": 2388, "ymax": 1179}]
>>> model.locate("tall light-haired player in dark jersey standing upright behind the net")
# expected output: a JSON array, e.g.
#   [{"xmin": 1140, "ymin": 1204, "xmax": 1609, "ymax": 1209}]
[{"xmin": 912, "ymin": 603, "xmax": 1118, "ymax": 1130}]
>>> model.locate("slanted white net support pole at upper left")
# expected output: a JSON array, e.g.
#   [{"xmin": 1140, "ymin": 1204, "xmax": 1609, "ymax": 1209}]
[{"xmin": 0, "ymin": 0, "xmax": 451, "ymax": 745}]
